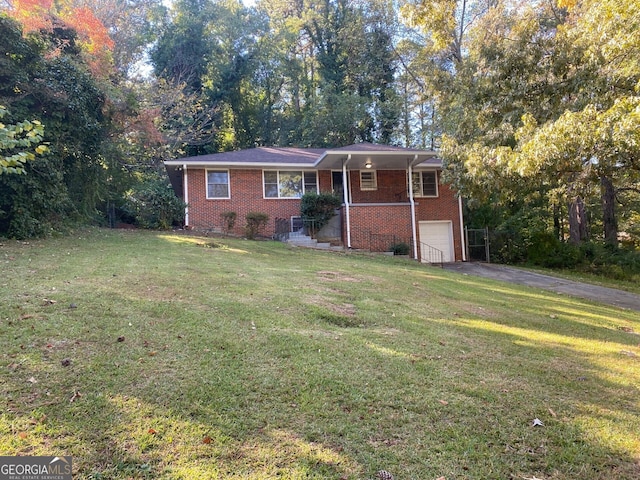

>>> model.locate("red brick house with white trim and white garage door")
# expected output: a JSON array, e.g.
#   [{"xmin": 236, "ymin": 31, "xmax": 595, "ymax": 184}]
[{"xmin": 164, "ymin": 143, "xmax": 466, "ymax": 262}]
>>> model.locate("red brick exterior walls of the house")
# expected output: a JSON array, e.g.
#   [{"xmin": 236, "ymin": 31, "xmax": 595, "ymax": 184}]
[{"xmin": 182, "ymin": 169, "xmax": 462, "ymax": 260}]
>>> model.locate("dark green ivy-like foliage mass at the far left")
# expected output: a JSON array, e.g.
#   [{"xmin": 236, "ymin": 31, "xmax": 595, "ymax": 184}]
[{"xmin": 0, "ymin": 15, "xmax": 106, "ymax": 238}]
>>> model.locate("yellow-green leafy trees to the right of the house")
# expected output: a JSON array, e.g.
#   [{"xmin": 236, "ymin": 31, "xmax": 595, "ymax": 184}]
[{"xmin": 406, "ymin": 0, "xmax": 640, "ymax": 261}]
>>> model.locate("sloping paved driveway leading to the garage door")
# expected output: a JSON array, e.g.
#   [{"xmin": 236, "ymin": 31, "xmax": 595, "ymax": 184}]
[{"xmin": 444, "ymin": 262, "xmax": 640, "ymax": 311}]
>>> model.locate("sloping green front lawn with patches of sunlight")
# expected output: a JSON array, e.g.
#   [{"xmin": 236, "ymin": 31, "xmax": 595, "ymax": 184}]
[{"xmin": 0, "ymin": 230, "xmax": 640, "ymax": 480}]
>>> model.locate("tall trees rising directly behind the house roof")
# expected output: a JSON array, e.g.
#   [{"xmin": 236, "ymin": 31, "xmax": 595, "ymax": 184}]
[{"xmin": 151, "ymin": 0, "xmax": 401, "ymax": 150}]
